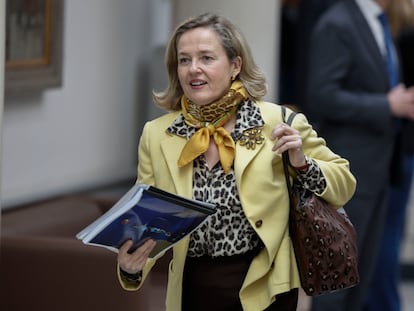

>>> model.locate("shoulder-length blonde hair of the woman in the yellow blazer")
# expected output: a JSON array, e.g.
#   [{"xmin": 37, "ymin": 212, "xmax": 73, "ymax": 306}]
[{"xmin": 153, "ymin": 13, "xmax": 267, "ymax": 110}]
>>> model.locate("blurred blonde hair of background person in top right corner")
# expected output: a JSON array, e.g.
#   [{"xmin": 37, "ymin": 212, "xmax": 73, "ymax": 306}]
[{"xmin": 387, "ymin": 0, "xmax": 414, "ymax": 37}]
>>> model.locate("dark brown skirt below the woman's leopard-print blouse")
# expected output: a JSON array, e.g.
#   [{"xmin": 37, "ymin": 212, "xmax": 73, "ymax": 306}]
[{"xmin": 182, "ymin": 252, "xmax": 298, "ymax": 311}]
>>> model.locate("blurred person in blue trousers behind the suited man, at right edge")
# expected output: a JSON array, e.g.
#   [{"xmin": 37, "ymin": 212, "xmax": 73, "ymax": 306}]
[{"xmin": 364, "ymin": 0, "xmax": 414, "ymax": 311}]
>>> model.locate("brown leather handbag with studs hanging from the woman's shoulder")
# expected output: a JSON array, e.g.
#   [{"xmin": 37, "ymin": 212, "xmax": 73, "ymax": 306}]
[{"xmin": 282, "ymin": 107, "xmax": 359, "ymax": 296}]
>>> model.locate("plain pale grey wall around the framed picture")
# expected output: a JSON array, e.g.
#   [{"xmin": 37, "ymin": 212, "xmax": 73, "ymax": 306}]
[{"xmin": 0, "ymin": 0, "xmax": 154, "ymax": 209}]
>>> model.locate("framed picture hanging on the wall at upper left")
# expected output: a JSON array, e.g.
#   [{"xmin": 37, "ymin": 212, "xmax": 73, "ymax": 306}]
[{"xmin": 5, "ymin": 0, "xmax": 63, "ymax": 94}]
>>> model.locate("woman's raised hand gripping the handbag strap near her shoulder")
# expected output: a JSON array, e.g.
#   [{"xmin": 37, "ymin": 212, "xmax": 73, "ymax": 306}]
[{"xmin": 270, "ymin": 123, "xmax": 306, "ymax": 167}]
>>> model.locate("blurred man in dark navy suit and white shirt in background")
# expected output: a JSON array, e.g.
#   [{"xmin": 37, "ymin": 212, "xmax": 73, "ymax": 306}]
[{"xmin": 304, "ymin": 0, "xmax": 414, "ymax": 311}]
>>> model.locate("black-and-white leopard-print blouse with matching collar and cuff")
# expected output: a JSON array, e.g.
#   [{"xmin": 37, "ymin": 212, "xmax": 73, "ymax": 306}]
[{"xmin": 167, "ymin": 100, "xmax": 326, "ymax": 257}]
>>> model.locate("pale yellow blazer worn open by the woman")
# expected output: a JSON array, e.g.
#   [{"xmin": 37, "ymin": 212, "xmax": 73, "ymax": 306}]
[{"xmin": 120, "ymin": 102, "xmax": 356, "ymax": 311}]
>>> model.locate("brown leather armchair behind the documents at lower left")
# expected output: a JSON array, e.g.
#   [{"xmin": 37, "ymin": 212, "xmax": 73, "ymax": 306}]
[{"xmin": 0, "ymin": 196, "xmax": 166, "ymax": 311}]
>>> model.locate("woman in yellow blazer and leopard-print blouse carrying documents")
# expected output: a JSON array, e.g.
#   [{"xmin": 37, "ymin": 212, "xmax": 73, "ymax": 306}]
[{"xmin": 118, "ymin": 14, "xmax": 355, "ymax": 311}]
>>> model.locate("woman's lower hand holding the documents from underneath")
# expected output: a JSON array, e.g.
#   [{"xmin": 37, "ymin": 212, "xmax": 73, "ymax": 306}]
[{"xmin": 118, "ymin": 240, "xmax": 157, "ymax": 274}]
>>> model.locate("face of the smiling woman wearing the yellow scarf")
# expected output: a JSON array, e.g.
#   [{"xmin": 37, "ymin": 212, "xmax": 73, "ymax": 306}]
[{"xmin": 177, "ymin": 28, "xmax": 242, "ymax": 106}]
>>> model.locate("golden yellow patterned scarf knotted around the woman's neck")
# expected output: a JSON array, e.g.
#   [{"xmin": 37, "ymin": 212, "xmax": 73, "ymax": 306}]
[{"xmin": 178, "ymin": 80, "xmax": 248, "ymax": 174}]
